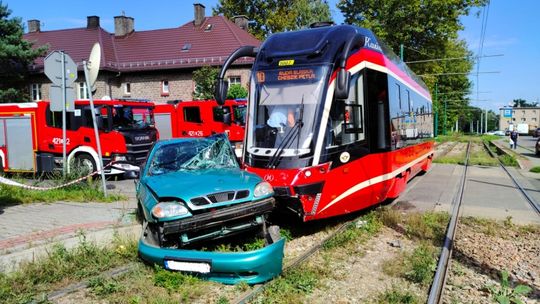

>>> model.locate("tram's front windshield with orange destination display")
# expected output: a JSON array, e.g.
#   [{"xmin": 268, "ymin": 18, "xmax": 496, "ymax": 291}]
[{"xmin": 247, "ymin": 65, "xmax": 330, "ymax": 157}]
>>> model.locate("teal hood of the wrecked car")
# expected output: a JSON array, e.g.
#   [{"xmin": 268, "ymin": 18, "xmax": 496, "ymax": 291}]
[{"xmin": 145, "ymin": 168, "xmax": 262, "ymax": 201}]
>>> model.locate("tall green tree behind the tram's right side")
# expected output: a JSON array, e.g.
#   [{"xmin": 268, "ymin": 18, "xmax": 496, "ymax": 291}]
[{"xmin": 338, "ymin": 0, "xmax": 487, "ymax": 134}]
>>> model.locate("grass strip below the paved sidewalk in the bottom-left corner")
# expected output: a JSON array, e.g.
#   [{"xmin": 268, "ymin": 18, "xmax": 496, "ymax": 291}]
[{"xmin": 0, "ymin": 234, "xmax": 137, "ymax": 303}]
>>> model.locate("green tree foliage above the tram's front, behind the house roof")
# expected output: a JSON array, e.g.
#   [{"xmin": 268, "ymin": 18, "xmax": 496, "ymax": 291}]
[{"xmin": 213, "ymin": 0, "xmax": 332, "ymax": 40}]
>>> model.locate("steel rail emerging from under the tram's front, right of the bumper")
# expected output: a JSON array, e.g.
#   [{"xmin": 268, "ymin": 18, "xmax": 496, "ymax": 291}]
[{"xmin": 232, "ymin": 218, "xmax": 358, "ymax": 304}]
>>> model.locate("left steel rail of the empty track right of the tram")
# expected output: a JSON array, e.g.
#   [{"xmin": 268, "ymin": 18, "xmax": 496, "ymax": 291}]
[{"xmin": 427, "ymin": 142, "xmax": 471, "ymax": 304}]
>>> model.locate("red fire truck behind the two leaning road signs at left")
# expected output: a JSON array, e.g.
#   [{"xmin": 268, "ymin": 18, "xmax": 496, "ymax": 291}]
[{"xmin": 0, "ymin": 100, "xmax": 158, "ymax": 176}]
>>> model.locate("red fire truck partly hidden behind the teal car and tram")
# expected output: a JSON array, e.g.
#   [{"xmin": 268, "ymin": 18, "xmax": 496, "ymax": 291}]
[{"xmin": 154, "ymin": 100, "xmax": 247, "ymax": 154}]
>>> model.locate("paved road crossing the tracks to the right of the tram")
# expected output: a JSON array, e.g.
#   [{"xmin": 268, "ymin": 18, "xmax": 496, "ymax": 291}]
[{"xmin": 395, "ymin": 151, "xmax": 540, "ymax": 224}]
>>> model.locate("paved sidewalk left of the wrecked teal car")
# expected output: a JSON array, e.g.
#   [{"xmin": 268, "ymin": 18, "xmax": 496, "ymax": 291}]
[{"xmin": 0, "ymin": 180, "xmax": 140, "ymax": 271}]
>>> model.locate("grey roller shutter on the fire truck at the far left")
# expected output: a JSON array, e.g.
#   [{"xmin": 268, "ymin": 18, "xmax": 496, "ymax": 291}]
[{"xmin": 0, "ymin": 114, "xmax": 34, "ymax": 171}]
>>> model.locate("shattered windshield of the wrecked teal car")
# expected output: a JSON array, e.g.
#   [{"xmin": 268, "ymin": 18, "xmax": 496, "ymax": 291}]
[{"xmin": 148, "ymin": 134, "xmax": 238, "ymax": 175}]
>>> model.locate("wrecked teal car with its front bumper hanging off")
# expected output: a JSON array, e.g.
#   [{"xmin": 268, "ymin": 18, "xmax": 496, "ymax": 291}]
[{"xmin": 136, "ymin": 134, "xmax": 285, "ymax": 284}]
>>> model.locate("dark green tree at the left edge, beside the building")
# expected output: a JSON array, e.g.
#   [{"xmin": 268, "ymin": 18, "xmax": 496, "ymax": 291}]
[{"xmin": 0, "ymin": 1, "xmax": 47, "ymax": 103}]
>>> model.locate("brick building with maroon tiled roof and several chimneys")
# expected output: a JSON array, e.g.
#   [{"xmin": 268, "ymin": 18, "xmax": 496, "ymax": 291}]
[{"xmin": 24, "ymin": 4, "xmax": 260, "ymax": 103}]
